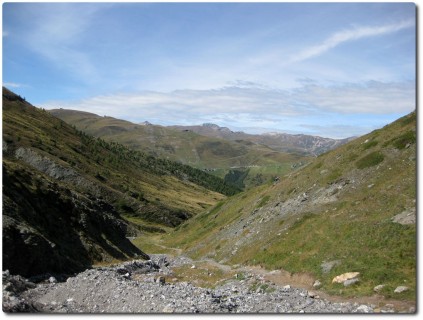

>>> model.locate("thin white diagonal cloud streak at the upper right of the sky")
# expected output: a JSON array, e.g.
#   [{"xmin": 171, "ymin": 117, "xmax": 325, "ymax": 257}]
[{"xmin": 291, "ymin": 20, "xmax": 415, "ymax": 62}]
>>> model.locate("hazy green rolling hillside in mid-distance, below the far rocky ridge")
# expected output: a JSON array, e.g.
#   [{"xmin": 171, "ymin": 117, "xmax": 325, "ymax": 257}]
[{"xmin": 50, "ymin": 109, "xmax": 308, "ymax": 188}]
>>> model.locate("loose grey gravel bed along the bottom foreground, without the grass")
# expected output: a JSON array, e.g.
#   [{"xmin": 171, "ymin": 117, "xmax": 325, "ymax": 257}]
[{"xmin": 3, "ymin": 255, "xmax": 400, "ymax": 314}]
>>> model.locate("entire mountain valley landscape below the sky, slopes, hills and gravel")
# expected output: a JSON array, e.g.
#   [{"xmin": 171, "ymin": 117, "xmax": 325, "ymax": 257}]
[{"xmin": 2, "ymin": 88, "xmax": 417, "ymax": 313}]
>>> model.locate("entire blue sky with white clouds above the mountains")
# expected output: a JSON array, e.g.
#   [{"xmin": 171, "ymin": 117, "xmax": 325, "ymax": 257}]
[{"xmin": 2, "ymin": 2, "xmax": 416, "ymax": 138}]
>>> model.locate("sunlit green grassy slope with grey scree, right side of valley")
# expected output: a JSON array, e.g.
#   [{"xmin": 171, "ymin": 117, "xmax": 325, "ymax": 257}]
[{"xmin": 164, "ymin": 113, "xmax": 416, "ymax": 300}]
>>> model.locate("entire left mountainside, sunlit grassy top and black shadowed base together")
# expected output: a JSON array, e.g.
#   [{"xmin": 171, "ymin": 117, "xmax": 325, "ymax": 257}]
[{"xmin": 2, "ymin": 88, "xmax": 235, "ymax": 276}]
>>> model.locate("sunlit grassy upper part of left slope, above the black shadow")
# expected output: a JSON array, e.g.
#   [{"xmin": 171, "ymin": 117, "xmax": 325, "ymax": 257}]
[{"xmin": 3, "ymin": 89, "xmax": 232, "ymax": 227}]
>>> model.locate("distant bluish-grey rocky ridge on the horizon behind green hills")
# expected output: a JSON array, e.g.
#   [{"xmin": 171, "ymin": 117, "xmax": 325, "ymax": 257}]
[{"xmin": 169, "ymin": 123, "xmax": 355, "ymax": 156}]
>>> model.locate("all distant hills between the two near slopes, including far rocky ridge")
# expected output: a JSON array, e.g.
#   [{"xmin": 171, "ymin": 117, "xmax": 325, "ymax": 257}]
[{"xmin": 49, "ymin": 109, "xmax": 324, "ymax": 189}]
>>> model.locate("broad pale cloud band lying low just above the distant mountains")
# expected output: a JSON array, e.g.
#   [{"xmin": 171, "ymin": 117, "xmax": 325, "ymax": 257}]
[{"xmin": 42, "ymin": 81, "xmax": 415, "ymax": 137}]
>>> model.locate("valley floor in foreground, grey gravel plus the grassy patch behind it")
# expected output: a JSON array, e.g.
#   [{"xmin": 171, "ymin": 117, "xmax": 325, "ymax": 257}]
[{"xmin": 3, "ymin": 252, "xmax": 415, "ymax": 313}]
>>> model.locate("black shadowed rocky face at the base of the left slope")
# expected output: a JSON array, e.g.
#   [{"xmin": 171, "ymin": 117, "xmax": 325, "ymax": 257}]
[{"xmin": 2, "ymin": 162, "xmax": 148, "ymax": 276}]
